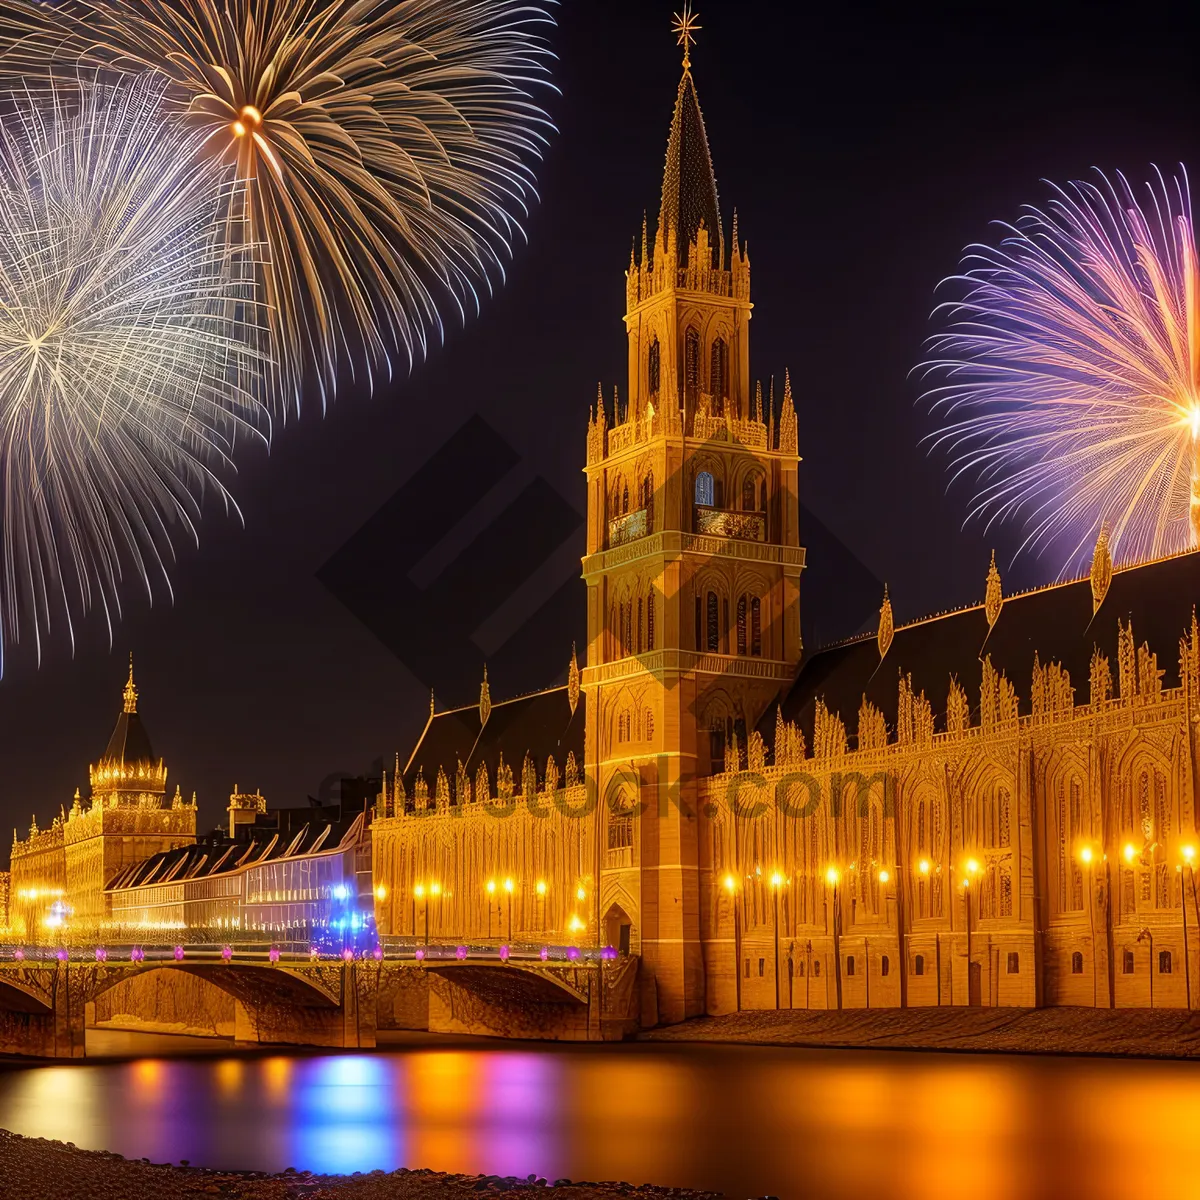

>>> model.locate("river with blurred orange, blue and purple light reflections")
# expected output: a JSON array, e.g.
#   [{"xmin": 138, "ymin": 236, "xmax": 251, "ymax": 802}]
[{"xmin": 0, "ymin": 1033, "xmax": 1200, "ymax": 1200}]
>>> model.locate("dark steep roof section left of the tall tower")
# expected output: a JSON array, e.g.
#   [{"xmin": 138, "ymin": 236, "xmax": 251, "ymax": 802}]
[{"xmin": 401, "ymin": 686, "xmax": 586, "ymax": 796}]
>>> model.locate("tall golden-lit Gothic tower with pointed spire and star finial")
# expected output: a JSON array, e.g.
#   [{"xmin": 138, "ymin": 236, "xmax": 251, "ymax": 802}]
[{"xmin": 583, "ymin": 12, "xmax": 804, "ymax": 1021}]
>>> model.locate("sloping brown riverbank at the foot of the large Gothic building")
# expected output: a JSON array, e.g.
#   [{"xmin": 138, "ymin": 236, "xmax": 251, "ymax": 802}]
[{"xmin": 641, "ymin": 1008, "xmax": 1200, "ymax": 1058}]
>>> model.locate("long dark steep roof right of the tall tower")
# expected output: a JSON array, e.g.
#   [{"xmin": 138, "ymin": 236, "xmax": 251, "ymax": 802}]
[{"xmin": 760, "ymin": 552, "xmax": 1200, "ymax": 746}]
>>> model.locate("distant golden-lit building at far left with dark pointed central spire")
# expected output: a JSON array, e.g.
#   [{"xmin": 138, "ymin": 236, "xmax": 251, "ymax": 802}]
[{"xmin": 10, "ymin": 661, "xmax": 196, "ymax": 938}]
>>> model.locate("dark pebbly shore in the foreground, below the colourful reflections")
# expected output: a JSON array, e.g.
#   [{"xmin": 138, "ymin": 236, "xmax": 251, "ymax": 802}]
[{"xmin": 0, "ymin": 1129, "xmax": 719, "ymax": 1200}]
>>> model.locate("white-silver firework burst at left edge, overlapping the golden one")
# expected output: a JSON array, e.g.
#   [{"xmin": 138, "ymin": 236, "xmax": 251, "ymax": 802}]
[{"xmin": 0, "ymin": 78, "xmax": 265, "ymax": 668}]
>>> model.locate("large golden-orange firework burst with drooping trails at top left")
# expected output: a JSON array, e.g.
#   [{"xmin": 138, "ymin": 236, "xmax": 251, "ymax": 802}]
[{"xmin": 5, "ymin": 0, "xmax": 550, "ymax": 410}]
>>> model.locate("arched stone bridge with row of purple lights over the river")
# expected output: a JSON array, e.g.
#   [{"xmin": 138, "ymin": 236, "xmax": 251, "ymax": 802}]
[{"xmin": 0, "ymin": 938, "xmax": 637, "ymax": 1058}]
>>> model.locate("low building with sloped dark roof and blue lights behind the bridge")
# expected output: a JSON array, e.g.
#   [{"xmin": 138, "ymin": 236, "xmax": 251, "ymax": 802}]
[{"xmin": 106, "ymin": 788, "xmax": 372, "ymax": 941}]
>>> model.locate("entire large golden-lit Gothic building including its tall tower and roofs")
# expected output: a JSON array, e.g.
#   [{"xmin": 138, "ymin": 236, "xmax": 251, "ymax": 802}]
[{"xmin": 371, "ymin": 30, "xmax": 1200, "ymax": 1022}]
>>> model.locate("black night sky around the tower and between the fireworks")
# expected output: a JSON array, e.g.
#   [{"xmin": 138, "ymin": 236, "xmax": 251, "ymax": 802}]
[{"xmin": 0, "ymin": 0, "xmax": 1200, "ymax": 833}]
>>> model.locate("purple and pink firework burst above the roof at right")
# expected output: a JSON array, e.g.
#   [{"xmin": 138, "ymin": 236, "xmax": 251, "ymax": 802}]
[{"xmin": 919, "ymin": 168, "xmax": 1200, "ymax": 575}]
